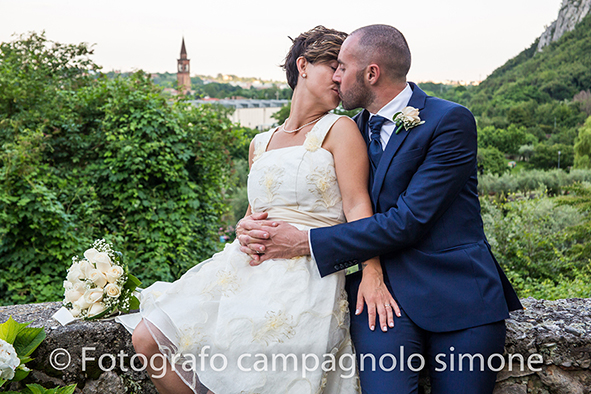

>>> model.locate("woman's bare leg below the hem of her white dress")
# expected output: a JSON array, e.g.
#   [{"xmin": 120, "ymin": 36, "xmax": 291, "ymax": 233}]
[{"xmin": 131, "ymin": 320, "xmax": 201, "ymax": 394}]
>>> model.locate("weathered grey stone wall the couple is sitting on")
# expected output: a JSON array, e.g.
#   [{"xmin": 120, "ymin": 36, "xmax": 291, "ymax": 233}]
[{"xmin": 0, "ymin": 298, "xmax": 591, "ymax": 394}]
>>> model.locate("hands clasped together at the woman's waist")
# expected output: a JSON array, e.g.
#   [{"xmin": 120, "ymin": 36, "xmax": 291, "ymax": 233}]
[{"xmin": 238, "ymin": 219, "xmax": 310, "ymax": 266}]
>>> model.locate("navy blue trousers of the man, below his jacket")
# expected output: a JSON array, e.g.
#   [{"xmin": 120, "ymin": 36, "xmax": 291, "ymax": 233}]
[{"xmin": 347, "ymin": 274, "xmax": 506, "ymax": 394}]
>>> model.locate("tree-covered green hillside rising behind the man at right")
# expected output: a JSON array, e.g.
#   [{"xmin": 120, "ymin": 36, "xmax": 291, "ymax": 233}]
[{"xmin": 458, "ymin": 15, "xmax": 591, "ymax": 169}]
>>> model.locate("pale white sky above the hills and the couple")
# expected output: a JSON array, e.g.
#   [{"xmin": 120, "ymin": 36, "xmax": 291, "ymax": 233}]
[{"xmin": 0, "ymin": 0, "xmax": 562, "ymax": 82}]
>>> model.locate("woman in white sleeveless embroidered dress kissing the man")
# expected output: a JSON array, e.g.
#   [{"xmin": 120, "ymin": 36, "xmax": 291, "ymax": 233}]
[{"xmin": 118, "ymin": 26, "xmax": 395, "ymax": 394}]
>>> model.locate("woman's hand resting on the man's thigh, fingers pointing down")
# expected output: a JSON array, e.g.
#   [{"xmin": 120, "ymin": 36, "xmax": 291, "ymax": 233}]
[{"xmin": 355, "ymin": 258, "xmax": 400, "ymax": 332}]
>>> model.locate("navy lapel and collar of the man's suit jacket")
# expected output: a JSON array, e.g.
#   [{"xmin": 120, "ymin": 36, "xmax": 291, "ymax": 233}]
[{"xmin": 372, "ymin": 82, "xmax": 427, "ymax": 207}]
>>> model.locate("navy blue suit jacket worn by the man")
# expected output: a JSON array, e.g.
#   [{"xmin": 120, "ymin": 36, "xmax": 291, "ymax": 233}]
[{"xmin": 310, "ymin": 83, "xmax": 522, "ymax": 332}]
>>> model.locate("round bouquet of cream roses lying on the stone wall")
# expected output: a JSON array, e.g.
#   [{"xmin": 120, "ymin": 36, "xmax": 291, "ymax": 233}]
[{"xmin": 64, "ymin": 239, "xmax": 140, "ymax": 320}]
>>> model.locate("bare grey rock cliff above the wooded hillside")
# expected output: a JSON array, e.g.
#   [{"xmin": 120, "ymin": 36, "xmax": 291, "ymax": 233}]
[{"xmin": 538, "ymin": 0, "xmax": 591, "ymax": 51}]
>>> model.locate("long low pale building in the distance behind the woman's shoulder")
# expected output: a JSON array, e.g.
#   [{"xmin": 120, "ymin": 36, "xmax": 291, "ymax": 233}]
[{"xmin": 191, "ymin": 99, "xmax": 289, "ymax": 130}]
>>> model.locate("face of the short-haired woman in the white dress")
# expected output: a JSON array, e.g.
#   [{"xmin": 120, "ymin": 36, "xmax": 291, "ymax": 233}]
[{"xmin": 306, "ymin": 60, "xmax": 340, "ymax": 111}]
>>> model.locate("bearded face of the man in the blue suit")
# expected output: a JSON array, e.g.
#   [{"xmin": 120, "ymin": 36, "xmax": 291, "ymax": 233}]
[{"xmin": 332, "ymin": 36, "xmax": 371, "ymax": 110}]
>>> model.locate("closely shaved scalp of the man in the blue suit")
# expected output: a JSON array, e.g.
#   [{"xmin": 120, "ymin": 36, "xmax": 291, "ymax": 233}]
[{"xmin": 349, "ymin": 25, "xmax": 410, "ymax": 82}]
